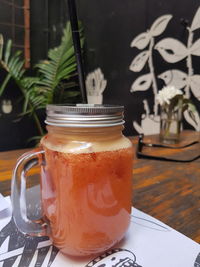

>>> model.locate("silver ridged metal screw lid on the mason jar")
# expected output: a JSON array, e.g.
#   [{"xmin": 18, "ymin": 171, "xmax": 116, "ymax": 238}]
[{"xmin": 45, "ymin": 104, "xmax": 124, "ymax": 128}]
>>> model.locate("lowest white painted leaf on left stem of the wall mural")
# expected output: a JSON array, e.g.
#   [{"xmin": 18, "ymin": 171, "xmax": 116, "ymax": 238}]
[{"xmin": 131, "ymin": 73, "xmax": 152, "ymax": 92}]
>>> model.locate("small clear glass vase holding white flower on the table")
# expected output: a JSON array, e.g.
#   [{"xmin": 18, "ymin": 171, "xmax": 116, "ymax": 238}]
[{"xmin": 160, "ymin": 104, "xmax": 182, "ymax": 144}]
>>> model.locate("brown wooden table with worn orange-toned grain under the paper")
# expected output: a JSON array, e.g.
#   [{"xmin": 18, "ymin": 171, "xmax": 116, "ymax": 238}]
[{"xmin": 0, "ymin": 131, "xmax": 200, "ymax": 242}]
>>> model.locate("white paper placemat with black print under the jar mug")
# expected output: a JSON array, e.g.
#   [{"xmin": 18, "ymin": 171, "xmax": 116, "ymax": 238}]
[{"xmin": 0, "ymin": 198, "xmax": 200, "ymax": 267}]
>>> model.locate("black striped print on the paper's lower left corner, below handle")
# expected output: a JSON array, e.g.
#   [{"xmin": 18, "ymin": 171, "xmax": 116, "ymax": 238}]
[{"xmin": 0, "ymin": 218, "xmax": 58, "ymax": 267}]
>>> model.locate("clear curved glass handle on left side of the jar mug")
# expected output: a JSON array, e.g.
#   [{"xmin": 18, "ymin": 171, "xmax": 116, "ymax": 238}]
[{"xmin": 11, "ymin": 148, "xmax": 47, "ymax": 236}]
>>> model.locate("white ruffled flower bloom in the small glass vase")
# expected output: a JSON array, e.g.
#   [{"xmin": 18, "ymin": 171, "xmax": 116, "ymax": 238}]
[{"xmin": 156, "ymin": 86, "xmax": 183, "ymax": 106}]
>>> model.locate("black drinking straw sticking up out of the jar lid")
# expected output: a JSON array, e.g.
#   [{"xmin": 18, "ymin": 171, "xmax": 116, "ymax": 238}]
[{"xmin": 68, "ymin": 0, "xmax": 87, "ymax": 103}]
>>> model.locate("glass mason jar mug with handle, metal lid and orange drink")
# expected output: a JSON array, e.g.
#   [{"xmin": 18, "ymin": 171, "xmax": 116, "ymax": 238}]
[{"xmin": 11, "ymin": 105, "xmax": 133, "ymax": 256}]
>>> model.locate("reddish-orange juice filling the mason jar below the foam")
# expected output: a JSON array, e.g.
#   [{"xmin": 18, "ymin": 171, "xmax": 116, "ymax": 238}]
[{"xmin": 42, "ymin": 143, "xmax": 133, "ymax": 255}]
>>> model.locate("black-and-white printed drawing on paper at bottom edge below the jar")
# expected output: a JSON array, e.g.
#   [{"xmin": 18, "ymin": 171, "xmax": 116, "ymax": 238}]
[{"xmin": 85, "ymin": 248, "xmax": 142, "ymax": 267}]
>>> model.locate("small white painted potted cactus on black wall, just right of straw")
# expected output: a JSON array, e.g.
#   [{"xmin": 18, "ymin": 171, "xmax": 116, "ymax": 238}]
[{"xmin": 86, "ymin": 68, "xmax": 107, "ymax": 104}]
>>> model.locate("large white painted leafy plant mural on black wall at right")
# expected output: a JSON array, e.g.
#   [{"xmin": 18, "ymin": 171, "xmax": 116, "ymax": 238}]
[{"xmin": 130, "ymin": 7, "xmax": 200, "ymax": 134}]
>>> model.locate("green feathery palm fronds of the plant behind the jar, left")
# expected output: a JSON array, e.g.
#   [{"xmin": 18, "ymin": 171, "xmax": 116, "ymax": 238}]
[{"xmin": 0, "ymin": 22, "xmax": 84, "ymax": 137}]
